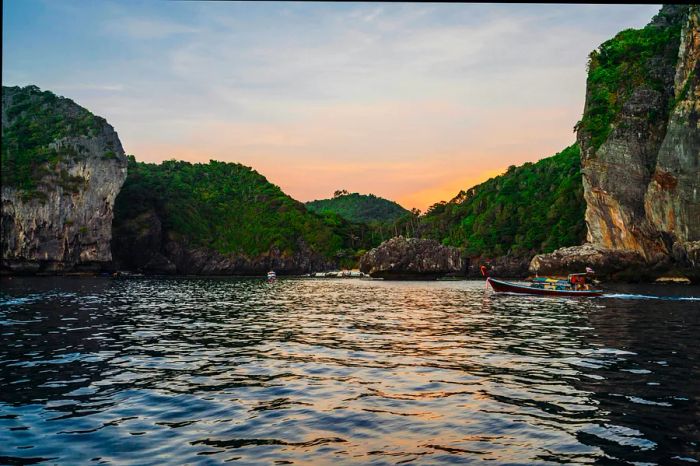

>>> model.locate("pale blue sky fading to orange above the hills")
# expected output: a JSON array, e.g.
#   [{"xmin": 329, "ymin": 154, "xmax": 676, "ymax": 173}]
[{"xmin": 2, "ymin": 0, "xmax": 660, "ymax": 210}]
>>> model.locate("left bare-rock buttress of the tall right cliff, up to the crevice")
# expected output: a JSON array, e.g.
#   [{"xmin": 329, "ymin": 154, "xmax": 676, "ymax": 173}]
[{"xmin": 577, "ymin": 7, "xmax": 680, "ymax": 260}]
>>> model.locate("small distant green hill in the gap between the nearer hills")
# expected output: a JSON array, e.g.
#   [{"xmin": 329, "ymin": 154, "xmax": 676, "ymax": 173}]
[{"xmin": 306, "ymin": 190, "xmax": 409, "ymax": 223}]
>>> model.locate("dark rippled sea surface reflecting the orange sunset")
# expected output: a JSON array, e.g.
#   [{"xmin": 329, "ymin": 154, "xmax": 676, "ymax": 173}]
[{"xmin": 0, "ymin": 278, "xmax": 700, "ymax": 465}]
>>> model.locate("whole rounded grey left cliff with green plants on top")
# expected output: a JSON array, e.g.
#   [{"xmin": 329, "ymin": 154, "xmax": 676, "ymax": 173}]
[{"xmin": 1, "ymin": 86, "xmax": 126, "ymax": 273}]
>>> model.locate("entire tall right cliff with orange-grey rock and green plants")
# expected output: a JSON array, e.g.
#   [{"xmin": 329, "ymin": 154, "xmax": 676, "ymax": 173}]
[{"xmin": 531, "ymin": 5, "xmax": 700, "ymax": 278}]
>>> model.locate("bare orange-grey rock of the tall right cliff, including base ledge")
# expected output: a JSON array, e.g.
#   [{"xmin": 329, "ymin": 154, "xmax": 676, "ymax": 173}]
[{"xmin": 530, "ymin": 5, "xmax": 700, "ymax": 279}]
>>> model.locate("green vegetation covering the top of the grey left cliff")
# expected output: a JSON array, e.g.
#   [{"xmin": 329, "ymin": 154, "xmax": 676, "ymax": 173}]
[{"xmin": 0, "ymin": 86, "xmax": 104, "ymax": 195}]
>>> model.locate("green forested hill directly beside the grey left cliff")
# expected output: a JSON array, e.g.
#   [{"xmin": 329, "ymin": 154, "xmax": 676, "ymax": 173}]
[{"xmin": 115, "ymin": 156, "xmax": 374, "ymax": 261}]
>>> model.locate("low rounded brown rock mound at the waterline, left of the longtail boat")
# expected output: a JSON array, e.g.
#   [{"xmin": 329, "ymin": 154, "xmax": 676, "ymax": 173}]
[{"xmin": 360, "ymin": 236, "xmax": 464, "ymax": 280}]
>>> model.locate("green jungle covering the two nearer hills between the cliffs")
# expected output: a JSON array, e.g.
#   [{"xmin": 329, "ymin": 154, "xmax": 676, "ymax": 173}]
[{"xmin": 115, "ymin": 145, "xmax": 585, "ymax": 267}]
